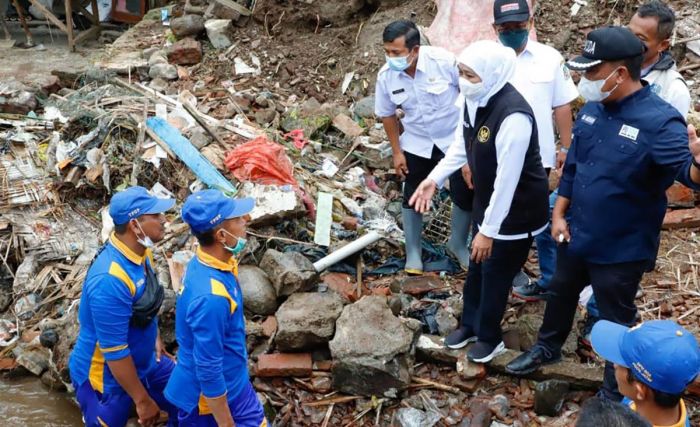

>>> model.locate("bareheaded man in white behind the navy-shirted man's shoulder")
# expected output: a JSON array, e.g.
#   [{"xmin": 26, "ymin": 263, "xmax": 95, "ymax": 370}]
[{"xmin": 628, "ymin": 0, "xmax": 690, "ymax": 117}]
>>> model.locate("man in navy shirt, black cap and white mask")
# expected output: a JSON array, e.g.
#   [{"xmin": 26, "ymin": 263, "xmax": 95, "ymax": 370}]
[{"xmin": 506, "ymin": 27, "xmax": 700, "ymax": 400}]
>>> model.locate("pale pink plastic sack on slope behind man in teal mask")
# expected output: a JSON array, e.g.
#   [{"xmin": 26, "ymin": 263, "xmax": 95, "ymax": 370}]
[{"xmin": 427, "ymin": 0, "xmax": 537, "ymax": 55}]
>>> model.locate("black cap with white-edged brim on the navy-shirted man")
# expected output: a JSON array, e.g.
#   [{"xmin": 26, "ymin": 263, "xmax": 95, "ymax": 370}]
[{"xmin": 566, "ymin": 26, "xmax": 646, "ymax": 71}]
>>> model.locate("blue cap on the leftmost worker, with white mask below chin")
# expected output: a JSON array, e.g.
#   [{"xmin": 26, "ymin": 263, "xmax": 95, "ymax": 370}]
[{"xmin": 109, "ymin": 187, "xmax": 175, "ymax": 225}]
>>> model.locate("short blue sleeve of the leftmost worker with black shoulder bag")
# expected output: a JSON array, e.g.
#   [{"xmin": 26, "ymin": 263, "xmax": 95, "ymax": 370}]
[{"xmin": 89, "ymin": 274, "xmax": 132, "ymax": 361}]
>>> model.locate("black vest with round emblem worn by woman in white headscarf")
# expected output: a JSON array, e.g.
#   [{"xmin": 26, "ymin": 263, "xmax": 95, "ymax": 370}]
[{"xmin": 464, "ymin": 83, "xmax": 549, "ymax": 235}]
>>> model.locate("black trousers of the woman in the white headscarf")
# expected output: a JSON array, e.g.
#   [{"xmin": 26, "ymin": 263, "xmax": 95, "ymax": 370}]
[{"xmin": 462, "ymin": 225, "xmax": 533, "ymax": 345}]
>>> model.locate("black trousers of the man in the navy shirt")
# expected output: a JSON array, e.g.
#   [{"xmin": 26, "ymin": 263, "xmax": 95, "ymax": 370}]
[{"xmin": 538, "ymin": 245, "xmax": 649, "ymax": 401}]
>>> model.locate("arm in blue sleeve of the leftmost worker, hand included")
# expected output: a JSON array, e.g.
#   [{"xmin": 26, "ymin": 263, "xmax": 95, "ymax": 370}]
[{"xmin": 89, "ymin": 275, "xmax": 160, "ymax": 426}]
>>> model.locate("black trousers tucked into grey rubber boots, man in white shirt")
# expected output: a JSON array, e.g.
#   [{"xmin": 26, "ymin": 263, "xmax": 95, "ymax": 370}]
[{"xmin": 403, "ymin": 145, "xmax": 474, "ymax": 212}]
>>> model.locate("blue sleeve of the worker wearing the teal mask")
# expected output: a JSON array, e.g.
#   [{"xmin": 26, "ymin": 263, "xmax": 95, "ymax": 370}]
[{"xmin": 187, "ymin": 295, "xmax": 230, "ymax": 398}]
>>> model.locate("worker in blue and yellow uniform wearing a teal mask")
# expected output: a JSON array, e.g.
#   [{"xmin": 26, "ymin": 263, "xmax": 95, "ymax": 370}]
[{"xmin": 165, "ymin": 190, "xmax": 267, "ymax": 427}]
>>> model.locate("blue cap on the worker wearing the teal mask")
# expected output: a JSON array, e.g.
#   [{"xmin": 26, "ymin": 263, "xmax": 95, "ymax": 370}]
[{"xmin": 182, "ymin": 190, "xmax": 255, "ymax": 234}]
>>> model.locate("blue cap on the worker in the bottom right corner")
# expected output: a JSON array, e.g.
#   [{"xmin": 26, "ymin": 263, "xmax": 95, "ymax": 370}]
[{"xmin": 591, "ymin": 320, "xmax": 700, "ymax": 394}]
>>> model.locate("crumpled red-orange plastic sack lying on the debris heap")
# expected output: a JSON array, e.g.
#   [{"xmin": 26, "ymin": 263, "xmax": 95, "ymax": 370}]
[{"xmin": 224, "ymin": 136, "xmax": 298, "ymax": 186}]
